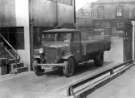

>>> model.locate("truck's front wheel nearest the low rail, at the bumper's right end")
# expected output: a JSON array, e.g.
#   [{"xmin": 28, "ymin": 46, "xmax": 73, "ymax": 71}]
[{"xmin": 63, "ymin": 58, "xmax": 75, "ymax": 77}]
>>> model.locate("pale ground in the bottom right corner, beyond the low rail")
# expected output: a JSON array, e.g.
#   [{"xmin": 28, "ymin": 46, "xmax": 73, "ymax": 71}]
[{"xmin": 87, "ymin": 66, "xmax": 135, "ymax": 98}]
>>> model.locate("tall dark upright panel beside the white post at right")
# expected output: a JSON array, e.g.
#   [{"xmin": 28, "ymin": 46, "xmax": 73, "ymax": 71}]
[{"xmin": 123, "ymin": 22, "xmax": 132, "ymax": 62}]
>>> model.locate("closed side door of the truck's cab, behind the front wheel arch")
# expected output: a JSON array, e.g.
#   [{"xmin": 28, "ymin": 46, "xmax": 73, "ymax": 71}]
[{"xmin": 71, "ymin": 31, "xmax": 82, "ymax": 62}]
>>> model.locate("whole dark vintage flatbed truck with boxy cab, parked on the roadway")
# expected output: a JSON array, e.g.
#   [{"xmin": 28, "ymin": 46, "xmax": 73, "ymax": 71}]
[{"xmin": 33, "ymin": 28, "xmax": 111, "ymax": 77}]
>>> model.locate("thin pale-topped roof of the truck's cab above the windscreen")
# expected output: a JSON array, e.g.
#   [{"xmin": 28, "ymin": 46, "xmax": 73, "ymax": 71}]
[{"xmin": 43, "ymin": 28, "xmax": 79, "ymax": 33}]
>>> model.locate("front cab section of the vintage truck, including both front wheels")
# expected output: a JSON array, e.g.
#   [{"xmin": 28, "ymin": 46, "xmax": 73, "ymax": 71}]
[{"xmin": 33, "ymin": 28, "xmax": 81, "ymax": 76}]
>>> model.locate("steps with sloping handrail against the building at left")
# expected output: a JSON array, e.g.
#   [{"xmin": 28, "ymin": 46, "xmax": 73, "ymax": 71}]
[{"xmin": 0, "ymin": 34, "xmax": 27, "ymax": 74}]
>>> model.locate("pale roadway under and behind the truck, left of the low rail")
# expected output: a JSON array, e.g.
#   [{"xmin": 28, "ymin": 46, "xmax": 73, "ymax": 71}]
[{"xmin": 0, "ymin": 38, "xmax": 123, "ymax": 98}]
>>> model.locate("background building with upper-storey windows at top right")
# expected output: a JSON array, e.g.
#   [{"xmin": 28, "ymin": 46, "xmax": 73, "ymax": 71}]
[{"xmin": 90, "ymin": 0, "xmax": 135, "ymax": 33}]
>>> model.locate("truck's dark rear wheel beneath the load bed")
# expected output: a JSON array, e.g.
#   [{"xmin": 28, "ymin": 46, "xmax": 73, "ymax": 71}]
[{"xmin": 94, "ymin": 52, "xmax": 104, "ymax": 67}]
